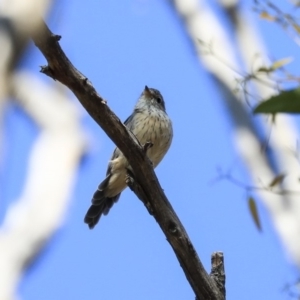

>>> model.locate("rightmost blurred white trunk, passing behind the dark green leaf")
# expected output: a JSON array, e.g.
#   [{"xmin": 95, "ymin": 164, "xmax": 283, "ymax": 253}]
[{"xmin": 219, "ymin": 0, "xmax": 300, "ymax": 266}]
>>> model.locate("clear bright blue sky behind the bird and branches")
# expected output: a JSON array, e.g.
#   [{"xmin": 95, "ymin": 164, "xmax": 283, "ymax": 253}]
[{"xmin": 0, "ymin": 0, "xmax": 299, "ymax": 300}]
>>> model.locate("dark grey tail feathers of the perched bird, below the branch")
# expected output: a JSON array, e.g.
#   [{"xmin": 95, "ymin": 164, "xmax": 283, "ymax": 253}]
[{"xmin": 84, "ymin": 178, "xmax": 121, "ymax": 229}]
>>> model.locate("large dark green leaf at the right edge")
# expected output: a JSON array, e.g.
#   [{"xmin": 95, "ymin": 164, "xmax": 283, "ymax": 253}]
[{"xmin": 254, "ymin": 88, "xmax": 300, "ymax": 114}]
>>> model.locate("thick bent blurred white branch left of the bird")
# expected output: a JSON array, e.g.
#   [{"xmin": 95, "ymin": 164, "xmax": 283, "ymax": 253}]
[{"xmin": 0, "ymin": 73, "xmax": 84, "ymax": 300}]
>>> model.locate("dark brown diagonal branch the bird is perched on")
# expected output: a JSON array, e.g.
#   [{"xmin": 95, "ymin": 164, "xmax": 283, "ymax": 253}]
[{"xmin": 32, "ymin": 22, "xmax": 224, "ymax": 300}]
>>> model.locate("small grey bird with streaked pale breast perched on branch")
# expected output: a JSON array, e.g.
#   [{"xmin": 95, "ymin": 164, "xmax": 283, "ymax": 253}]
[{"xmin": 84, "ymin": 86, "xmax": 173, "ymax": 229}]
